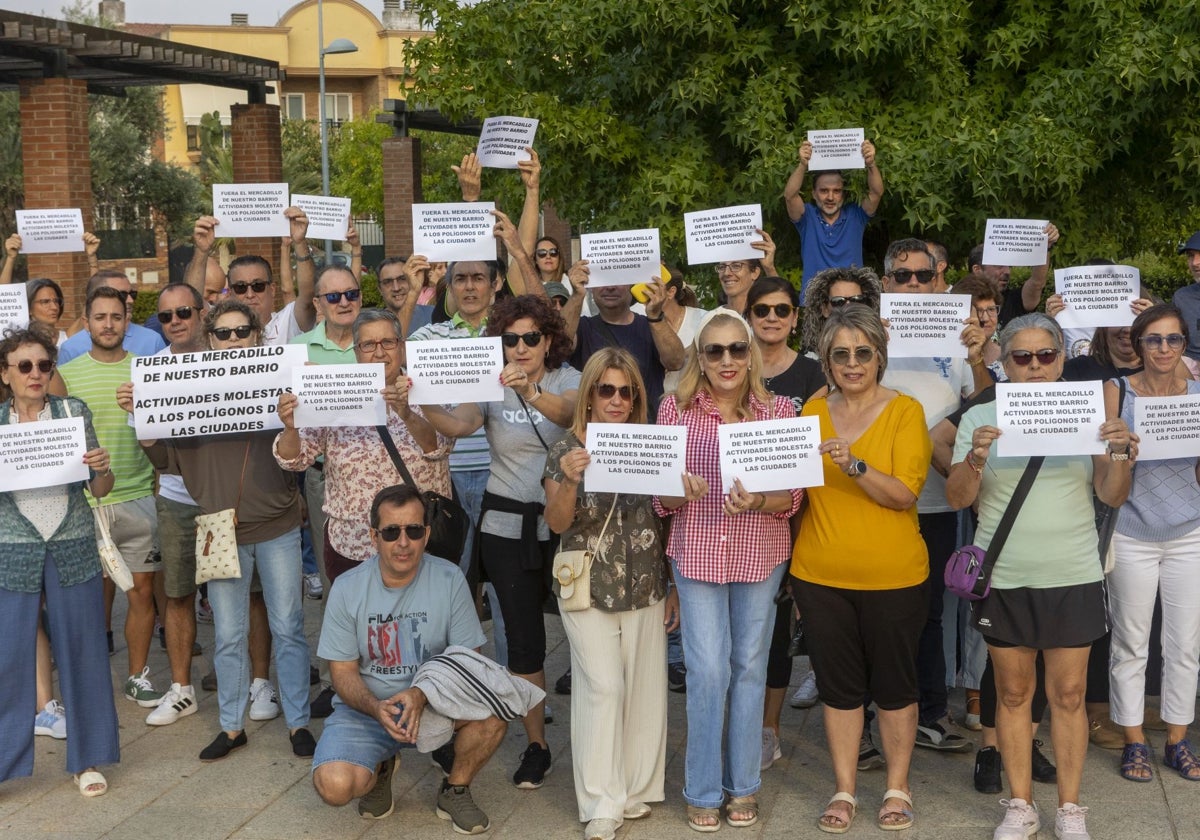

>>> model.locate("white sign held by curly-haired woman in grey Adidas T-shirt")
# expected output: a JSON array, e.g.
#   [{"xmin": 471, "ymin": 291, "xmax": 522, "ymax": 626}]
[{"xmin": 404, "ymin": 336, "xmax": 504, "ymax": 406}]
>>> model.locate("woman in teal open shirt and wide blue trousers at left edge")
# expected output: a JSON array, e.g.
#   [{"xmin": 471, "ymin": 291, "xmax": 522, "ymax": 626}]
[{"xmin": 0, "ymin": 330, "xmax": 120, "ymax": 797}]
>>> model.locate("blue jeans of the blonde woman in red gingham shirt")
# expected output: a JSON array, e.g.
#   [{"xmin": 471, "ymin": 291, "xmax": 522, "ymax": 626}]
[{"xmin": 674, "ymin": 563, "xmax": 787, "ymax": 808}]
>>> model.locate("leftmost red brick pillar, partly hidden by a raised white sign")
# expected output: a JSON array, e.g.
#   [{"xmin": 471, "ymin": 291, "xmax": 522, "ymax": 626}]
[{"xmin": 20, "ymin": 78, "xmax": 96, "ymax": 323}]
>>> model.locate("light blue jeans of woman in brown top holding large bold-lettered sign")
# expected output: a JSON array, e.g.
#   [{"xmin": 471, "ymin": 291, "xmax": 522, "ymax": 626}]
[{"xmin": 209, "ymin": 528, "xmax": 308, "ymax": 732}]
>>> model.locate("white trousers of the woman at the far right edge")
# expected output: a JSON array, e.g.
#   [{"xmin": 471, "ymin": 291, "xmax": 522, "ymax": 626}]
[{"xmin": 1109, "ymin": 528, "xmax": 1200, "ymax": 726}]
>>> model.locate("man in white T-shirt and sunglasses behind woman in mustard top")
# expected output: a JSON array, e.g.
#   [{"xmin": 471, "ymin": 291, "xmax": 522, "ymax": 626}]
[{"xmin": 882, "ymin": 239, "xmax": 991, "ymax": 752}]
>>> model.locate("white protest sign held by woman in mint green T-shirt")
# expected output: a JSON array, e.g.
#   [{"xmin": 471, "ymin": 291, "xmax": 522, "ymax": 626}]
[{"xmin": 995, "ymin": 382, "xmax": 1105, "ymax": 458}]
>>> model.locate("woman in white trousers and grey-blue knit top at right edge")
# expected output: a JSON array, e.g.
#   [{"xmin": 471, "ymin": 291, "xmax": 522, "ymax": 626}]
[{"xmin": 1104, "ymin": 304, "xmax": 1200, "ymax": 781}]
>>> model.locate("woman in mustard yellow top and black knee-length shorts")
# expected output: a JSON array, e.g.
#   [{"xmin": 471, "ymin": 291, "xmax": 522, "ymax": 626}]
[{"xmin": 792, "ymin": 304, "xmax": 932, "ymax": 834}]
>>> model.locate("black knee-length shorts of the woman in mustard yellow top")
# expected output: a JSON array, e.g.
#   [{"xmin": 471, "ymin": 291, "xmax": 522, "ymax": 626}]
[{"xmin": 792, "ymin": 577, "xmax": 929, "ymax": 710}]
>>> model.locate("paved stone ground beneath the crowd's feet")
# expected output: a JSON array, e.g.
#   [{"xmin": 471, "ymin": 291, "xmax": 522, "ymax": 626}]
[{"xmin": 0, "ymin": 596, "xmax": 1200, "ymax": 840}]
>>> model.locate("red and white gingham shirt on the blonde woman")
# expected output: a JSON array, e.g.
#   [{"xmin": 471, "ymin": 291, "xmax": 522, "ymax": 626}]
[{"xmin": 654, "ymin": 390, "xmax": 804, "ymax": 583}]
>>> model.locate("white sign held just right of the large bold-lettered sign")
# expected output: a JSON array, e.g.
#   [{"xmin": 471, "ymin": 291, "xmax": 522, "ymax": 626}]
[{"xmin": 292, "ymin": 362, "xmax": 388, "ymax": 428}]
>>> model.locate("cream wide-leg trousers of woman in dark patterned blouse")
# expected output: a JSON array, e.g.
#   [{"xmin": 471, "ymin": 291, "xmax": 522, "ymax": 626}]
[{"xmin": 562, "ymin": 601, "xmax": 667, "ymax": 822}]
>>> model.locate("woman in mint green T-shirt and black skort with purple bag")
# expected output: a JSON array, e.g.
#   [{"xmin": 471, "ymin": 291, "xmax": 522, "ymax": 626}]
[{"xmin": 946, "ymin": 313, "xmax": 1135, "ymax": 840}]
